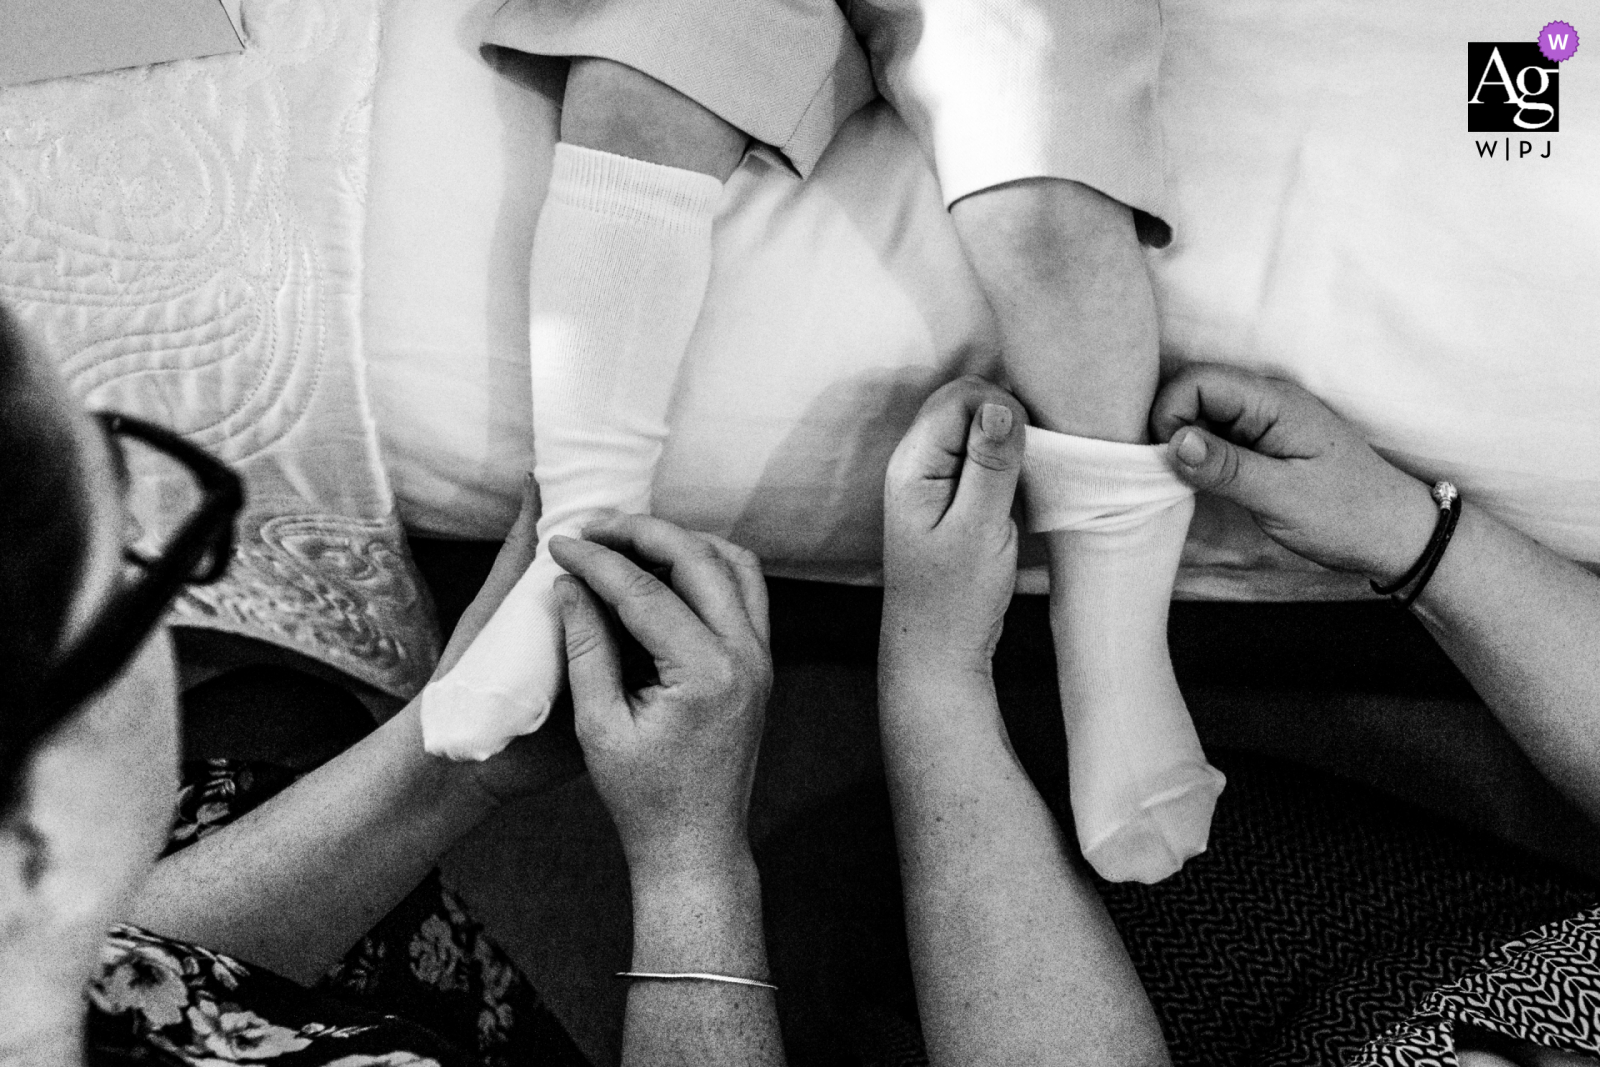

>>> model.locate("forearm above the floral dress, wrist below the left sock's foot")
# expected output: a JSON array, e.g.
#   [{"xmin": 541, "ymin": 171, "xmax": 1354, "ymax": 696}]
[{"xmin": 131, "ymin": 702, "xmax": 494, "ymax": 984}]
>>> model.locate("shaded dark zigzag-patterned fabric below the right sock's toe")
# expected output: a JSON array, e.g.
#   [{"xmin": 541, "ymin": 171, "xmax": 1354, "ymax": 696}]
[{"xmin": 1104, "ymin": 755, "xmax": 1600, "ymax": 1067}]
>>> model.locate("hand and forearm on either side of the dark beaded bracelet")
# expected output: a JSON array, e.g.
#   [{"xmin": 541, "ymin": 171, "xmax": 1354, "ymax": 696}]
[{"xmin": 1152, "ymin": 365, "xmax": 1600, "ymax": 822}]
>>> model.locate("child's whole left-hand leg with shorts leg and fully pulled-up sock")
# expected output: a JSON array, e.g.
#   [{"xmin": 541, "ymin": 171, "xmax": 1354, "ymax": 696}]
[{"xmin": 422, "ymin": 0, "xmax": 870, "ymax": 758}]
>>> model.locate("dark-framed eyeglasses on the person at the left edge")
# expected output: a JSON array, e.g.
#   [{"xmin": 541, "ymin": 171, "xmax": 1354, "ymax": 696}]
[{"xmin": 36, "ymin": 413, "xmax": 245, "ymax": 723}]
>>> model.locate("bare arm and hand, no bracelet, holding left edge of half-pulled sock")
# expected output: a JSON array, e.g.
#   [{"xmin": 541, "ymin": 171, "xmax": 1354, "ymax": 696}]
[{"xmin": 880, "ymin": 379, "xmax": 1166, "ymax": 1067}]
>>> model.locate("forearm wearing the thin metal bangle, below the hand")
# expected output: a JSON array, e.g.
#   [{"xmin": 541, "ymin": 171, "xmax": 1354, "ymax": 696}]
[{"xmin": 622, "ymin": 848, "xmax": 784, "ymax": 1067}]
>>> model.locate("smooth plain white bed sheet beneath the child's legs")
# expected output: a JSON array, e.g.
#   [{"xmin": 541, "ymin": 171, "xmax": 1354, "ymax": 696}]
[{"xmin": 365, "ymin": 0, "xmax": 1600, "ymax": 600}]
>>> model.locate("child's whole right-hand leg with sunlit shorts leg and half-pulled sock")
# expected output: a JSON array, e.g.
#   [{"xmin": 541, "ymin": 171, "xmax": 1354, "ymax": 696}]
[{"xmin": 854, "ymin": 0, "xmax": 1222, "ymax": 881}]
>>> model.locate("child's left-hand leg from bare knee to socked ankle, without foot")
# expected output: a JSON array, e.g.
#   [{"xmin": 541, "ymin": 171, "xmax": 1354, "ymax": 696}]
[{"xmin": 528, "ymin": 59, "xmax": 746, "ymax": 550}]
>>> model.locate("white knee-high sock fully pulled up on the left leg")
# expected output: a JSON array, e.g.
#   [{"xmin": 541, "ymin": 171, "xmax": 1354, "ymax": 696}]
[{"xmin": 422, "ymin": 144, "xmax": 722, "ymax": 760}]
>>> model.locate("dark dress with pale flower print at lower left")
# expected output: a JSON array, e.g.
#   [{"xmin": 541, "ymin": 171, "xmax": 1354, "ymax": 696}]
[{"xmin": 90, "ymin": 760, "xmax": 587, "ymax": 1067}]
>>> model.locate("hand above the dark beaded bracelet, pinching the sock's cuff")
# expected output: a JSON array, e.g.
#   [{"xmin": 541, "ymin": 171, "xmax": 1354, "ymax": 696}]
[{"xmin": 1150, "ymin": 363, "xmax": 1438, "ymax": 582}]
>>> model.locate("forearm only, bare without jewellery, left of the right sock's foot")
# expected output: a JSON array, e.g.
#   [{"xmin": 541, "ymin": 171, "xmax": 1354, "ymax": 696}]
[{"xmin": 880, "ymin": 659, "xmax": 1166, "ymax": 1067}]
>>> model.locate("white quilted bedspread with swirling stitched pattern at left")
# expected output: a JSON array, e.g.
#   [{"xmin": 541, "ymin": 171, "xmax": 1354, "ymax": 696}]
[{"xmin": 0, "ymin": 0, "xmax": 437, "ymax": 696}]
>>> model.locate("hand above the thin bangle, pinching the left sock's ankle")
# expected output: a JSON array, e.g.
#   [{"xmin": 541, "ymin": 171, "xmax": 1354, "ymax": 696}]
[{"xmin": 550, "ymin": 515, "xmax": 773, "ymax": 878}]
